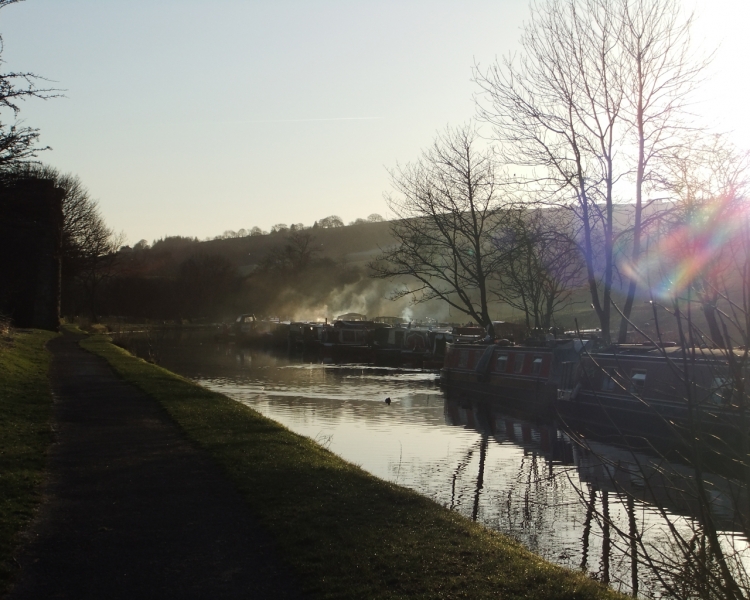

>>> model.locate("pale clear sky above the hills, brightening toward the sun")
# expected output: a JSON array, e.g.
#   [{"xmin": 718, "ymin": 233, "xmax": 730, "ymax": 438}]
[{"xmin": 0, "ymin": 0, "xmax": 750, "ymax": 244}]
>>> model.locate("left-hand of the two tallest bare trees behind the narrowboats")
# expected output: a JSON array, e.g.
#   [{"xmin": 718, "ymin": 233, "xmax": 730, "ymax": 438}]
[{"xmin": 476, "ymin": 0, "xmax": 626, "ymax": 339}]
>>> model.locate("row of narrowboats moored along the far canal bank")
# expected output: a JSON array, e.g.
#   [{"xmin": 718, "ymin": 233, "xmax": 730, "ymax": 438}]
[{"xmin": 224, "ymin": 315, "xmax": 750, "ymax": 472}]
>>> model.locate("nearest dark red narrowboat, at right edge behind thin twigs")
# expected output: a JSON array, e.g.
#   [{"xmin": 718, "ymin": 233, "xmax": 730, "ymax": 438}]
[{"xmin": 556, "ymin": 344, "xmax": 749, "ymax": 461}]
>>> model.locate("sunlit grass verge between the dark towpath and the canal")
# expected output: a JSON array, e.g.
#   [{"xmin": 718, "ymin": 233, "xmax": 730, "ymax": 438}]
[{"xmin": 81, "ymin": 336, "xmax": 622, "ymax": 599}]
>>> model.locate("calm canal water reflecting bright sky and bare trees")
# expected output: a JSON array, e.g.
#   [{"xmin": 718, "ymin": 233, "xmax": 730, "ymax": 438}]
[{"xmin": 117, "ymin": 331, "xmax": 750, "ymax": 597}]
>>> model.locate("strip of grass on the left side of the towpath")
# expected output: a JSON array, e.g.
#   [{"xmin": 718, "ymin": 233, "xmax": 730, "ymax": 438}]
[{"xmin": 0, "ymin": 331, "xmax": 55, "ymax": 595}]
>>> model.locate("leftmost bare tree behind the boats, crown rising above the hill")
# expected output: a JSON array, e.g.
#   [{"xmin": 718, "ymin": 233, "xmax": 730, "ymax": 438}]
[{"xmin": 370, "ymin": 125, "xmax": 505, "ymax": 327}]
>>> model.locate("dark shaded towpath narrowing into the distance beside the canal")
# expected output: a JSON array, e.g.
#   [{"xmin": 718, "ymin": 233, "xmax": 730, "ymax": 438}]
[{"xmin": 8, "ymin": 334, "xmax": 303, "ymax": 600}]
